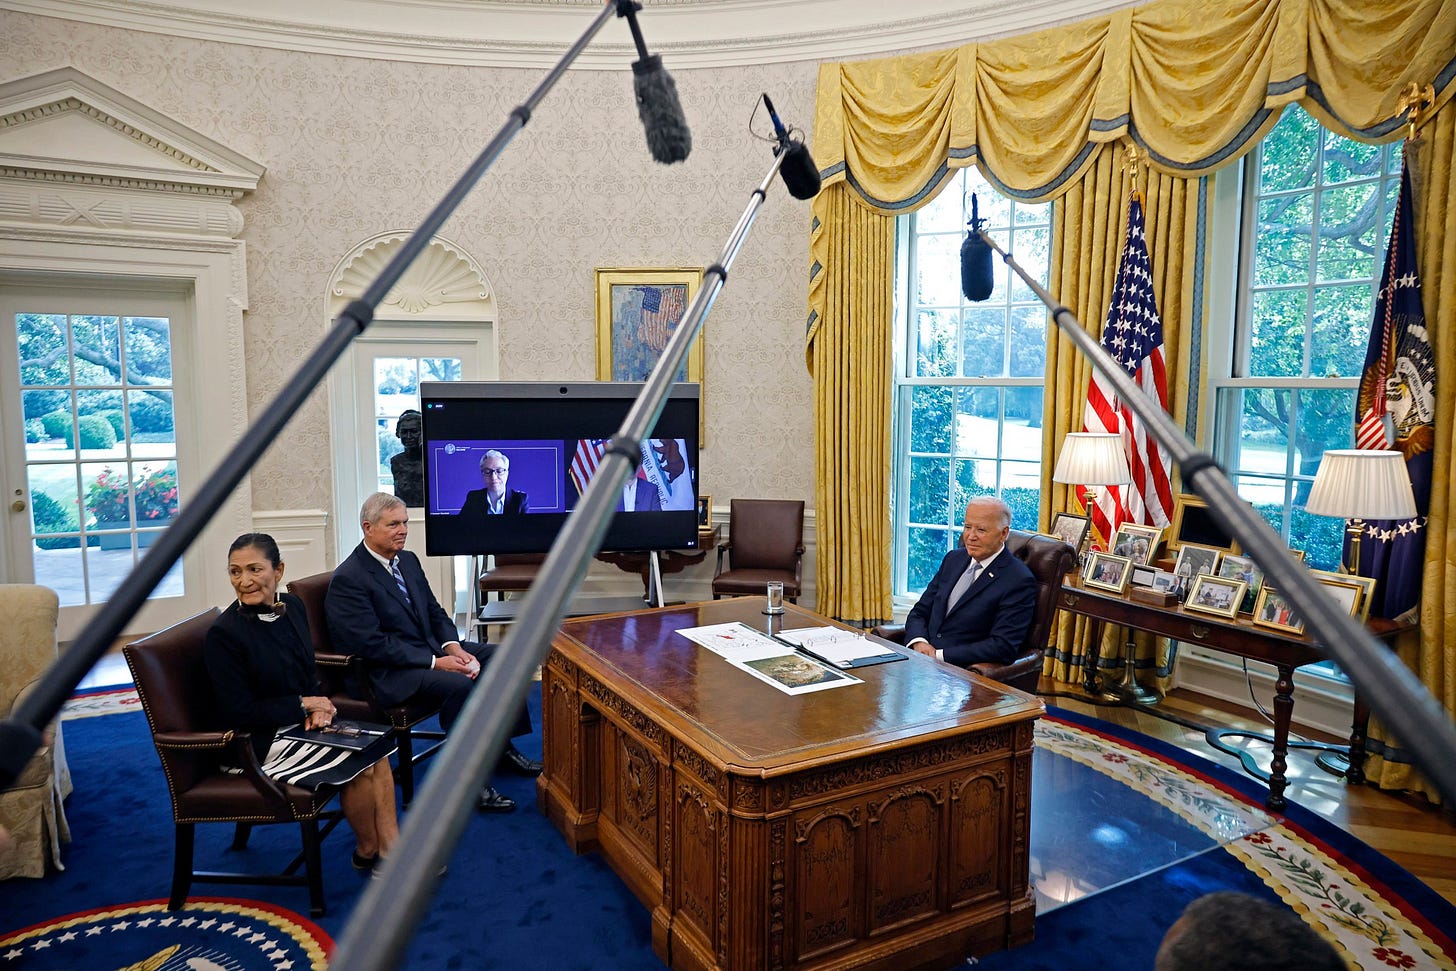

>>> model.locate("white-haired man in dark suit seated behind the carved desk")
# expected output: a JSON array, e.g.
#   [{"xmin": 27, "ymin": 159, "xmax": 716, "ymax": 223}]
[{"xmin": 906, "ymin": 496, "xmax": 1037, "ymax": 668}]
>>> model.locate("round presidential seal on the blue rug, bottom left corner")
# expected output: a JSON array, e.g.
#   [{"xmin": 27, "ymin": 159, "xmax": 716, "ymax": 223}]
[{"xmin": 0, "ymin": 897, "xmax": 333, "ymax": 971}]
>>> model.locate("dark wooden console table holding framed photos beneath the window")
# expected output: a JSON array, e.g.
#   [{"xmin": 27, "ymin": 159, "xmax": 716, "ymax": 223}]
[{"xmin": 1060, "ymin": 575, "xmax": 1411, "ymax": 812}]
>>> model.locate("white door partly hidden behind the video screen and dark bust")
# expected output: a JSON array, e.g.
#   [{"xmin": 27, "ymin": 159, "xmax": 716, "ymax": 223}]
[{"xmin": 333, "ymin": 320, "xmax": 498, "ymax": 610}]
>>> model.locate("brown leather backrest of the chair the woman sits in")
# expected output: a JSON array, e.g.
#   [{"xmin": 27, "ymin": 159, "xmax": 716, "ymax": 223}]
[{"xmin": 121, "ymin": 607, "xmax": 221, "ymax": 808}]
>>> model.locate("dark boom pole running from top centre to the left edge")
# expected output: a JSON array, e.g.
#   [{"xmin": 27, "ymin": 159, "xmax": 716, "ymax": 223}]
[{"xmin": 0, "ymin": 0, "xmax": 622, "ymax": 790}]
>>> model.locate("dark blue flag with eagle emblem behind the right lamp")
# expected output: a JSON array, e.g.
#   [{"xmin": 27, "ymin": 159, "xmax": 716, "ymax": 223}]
[{"xmin": 1344, "ymin": 155, "xmax": 1436, "ymax": 617}]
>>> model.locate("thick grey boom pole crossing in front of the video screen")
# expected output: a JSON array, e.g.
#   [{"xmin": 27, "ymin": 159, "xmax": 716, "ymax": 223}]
[{"xmin": 332, "ymin": 140, "xmax": 783, "ymax": 971}]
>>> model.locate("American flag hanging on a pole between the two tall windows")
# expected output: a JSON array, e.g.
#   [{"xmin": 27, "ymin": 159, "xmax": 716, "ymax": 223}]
[{"xmin": 1083, "ymin": 192, "xmax": 1174, "ymax": 540}]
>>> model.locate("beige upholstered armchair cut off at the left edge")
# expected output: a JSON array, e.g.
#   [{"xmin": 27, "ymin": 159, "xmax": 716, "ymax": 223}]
[{"xmin": 0, "ymin": 584, "xmax": 71, "ymax": 879}]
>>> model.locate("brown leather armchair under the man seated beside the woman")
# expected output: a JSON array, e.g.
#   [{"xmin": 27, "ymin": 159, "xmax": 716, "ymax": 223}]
[{"xmin": 288, "ymin": 574, "xmax": 446, "ymax": 806}]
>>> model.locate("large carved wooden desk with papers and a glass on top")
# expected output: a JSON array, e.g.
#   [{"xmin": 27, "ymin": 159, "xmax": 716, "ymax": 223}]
[{"xmin": 536, "ymin": 597, "xmax": 1045, "ymax": 971}]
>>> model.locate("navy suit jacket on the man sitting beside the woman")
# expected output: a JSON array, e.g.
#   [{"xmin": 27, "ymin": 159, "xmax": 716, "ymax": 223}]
[{"xmin": 323, "ymin": 543, "xmax": 460, "ymax": 705}]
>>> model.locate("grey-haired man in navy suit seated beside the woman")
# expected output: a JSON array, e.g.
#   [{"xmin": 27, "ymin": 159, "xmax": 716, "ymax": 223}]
[{"xmin": 325, "ymin": 492, "xmax": 542, "ymax": 812}]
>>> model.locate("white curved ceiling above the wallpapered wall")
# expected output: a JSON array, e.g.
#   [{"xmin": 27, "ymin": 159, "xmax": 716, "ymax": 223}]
[{"xmin": 0, "ymin": 0, "xmax": 1146, "ymax": 70}]
